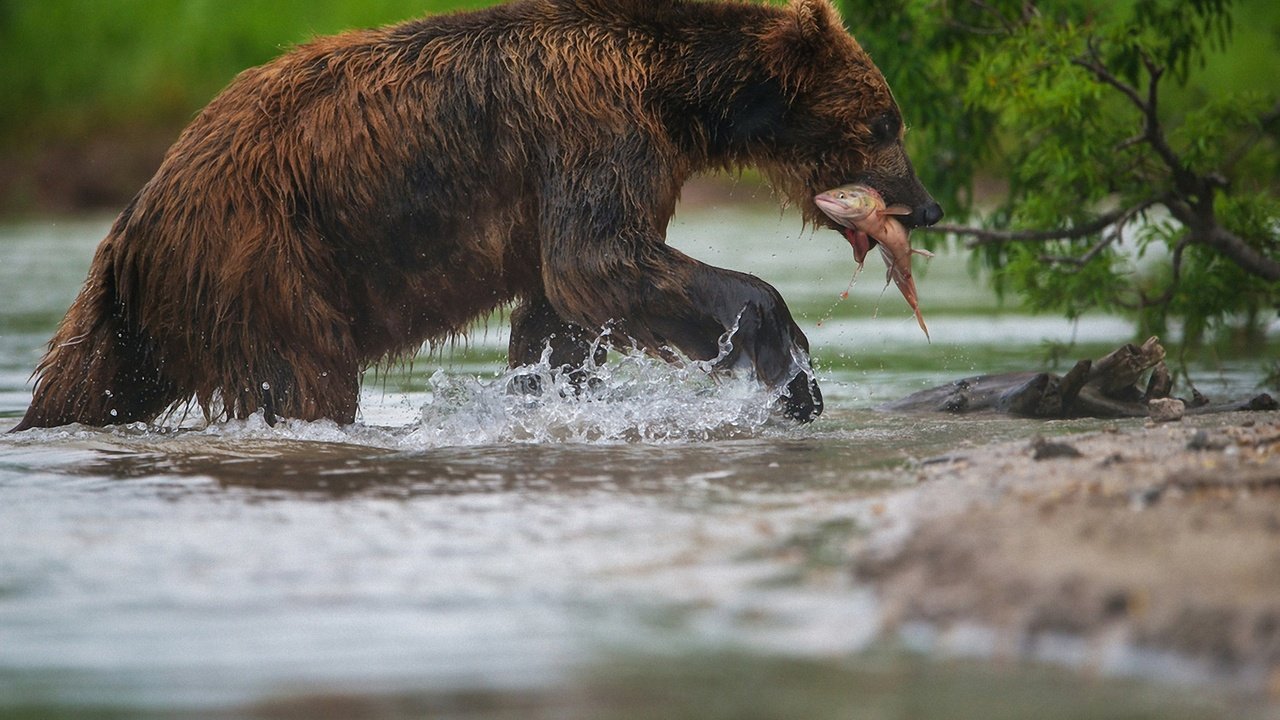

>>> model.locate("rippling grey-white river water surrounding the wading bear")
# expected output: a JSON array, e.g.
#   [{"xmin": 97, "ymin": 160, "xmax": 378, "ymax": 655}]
[{"xmin": 0, "ymin": 208, "xmax": 1275, "ymax": 717}]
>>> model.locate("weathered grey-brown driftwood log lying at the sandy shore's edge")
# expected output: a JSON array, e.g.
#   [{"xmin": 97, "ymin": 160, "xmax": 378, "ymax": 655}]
[{"xmin": 879, "ymin": 337, "xmax": 1277, "ymax": 418}]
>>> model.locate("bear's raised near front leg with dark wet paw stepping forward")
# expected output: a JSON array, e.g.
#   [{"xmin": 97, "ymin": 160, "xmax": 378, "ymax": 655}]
[{"xmin": 539, "ymin": 158, "xmax": 822, "ymax": 421}]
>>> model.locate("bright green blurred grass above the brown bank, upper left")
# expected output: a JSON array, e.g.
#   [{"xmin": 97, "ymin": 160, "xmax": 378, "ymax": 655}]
[{"xmin": 0, "ymin": 0, "xmax": 497, "ymax": 146}]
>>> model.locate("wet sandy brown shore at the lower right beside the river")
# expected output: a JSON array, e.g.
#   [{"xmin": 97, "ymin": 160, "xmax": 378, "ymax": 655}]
[{"xmin": 855, "ymin": 413, "xmax": 1280, "ymax": 698}]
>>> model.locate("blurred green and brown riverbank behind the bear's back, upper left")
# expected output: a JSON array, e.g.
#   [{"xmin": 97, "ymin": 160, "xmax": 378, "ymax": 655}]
[{"xmin": 0, "ymin": 0, "xmax": 495, "ymax": 217}]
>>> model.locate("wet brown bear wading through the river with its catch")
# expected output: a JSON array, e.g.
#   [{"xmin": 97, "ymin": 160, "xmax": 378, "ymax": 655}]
[{"xmin": 14, "ymin": 0, "xmax": 941, "ymax": 429}]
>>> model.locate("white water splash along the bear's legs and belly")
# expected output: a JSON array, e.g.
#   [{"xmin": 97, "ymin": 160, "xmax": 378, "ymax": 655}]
[{"xmin": 2, "ymin": 324, "xmax": 809, "ymax": 451}]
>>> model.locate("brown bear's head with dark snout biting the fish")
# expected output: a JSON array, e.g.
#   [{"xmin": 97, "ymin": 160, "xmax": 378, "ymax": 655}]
[{"xmin": 759, "ymin": 0, "xmax": 942, "ymax": 227}]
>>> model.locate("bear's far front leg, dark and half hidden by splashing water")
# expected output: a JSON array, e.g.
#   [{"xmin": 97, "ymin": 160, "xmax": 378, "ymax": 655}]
[{"xmin": 507, "ymin": 295, "xmax": 608, "ymax": 395}]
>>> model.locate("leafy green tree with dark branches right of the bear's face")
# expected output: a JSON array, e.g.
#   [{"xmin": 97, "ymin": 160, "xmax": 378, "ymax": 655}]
[{"xmin": 844, "ymin": 0, "xmax": 1280, "ymax": 343}]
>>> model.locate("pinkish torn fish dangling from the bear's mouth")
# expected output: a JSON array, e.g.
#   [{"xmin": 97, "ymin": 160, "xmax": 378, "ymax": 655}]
[{"xmin": 813, "ymin": 184, "xmax": 933, "ymax": 340}]
